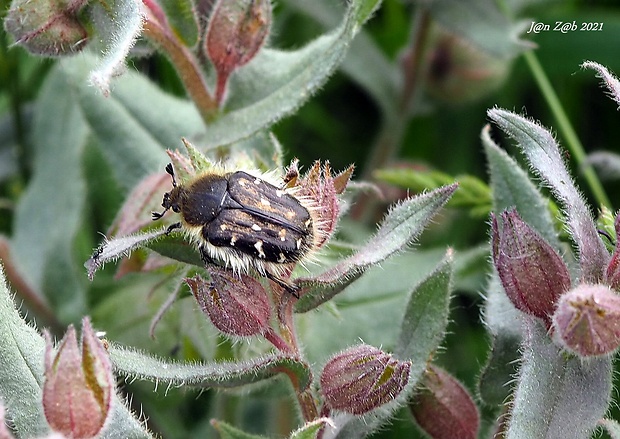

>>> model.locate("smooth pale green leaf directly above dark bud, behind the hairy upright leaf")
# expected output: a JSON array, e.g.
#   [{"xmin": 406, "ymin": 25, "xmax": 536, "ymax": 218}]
[{"xmin": 480, "ymin": 125, "xmax": 560, "ymax": 251}]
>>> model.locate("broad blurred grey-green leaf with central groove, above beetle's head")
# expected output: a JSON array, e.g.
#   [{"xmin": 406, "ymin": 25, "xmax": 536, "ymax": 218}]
[{"xmin": 61, "ymin": 52, "xmax": 199, "ymax": 189}]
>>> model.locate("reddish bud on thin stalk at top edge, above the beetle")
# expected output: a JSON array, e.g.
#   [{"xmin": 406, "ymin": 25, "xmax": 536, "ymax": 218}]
[{"xmin": 205, "ymin": 0, "xmax": 271, "ymax": 104}]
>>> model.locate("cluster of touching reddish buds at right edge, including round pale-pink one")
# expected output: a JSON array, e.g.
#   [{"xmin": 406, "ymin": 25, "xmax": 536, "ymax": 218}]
[{"xmin": 492, "ymin": 210, "xmax": 620, "ymax": 357}]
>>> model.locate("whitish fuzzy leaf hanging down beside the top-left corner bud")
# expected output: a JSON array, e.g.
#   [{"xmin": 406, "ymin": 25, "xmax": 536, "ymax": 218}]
[{"xmin": 89, "ymin": 0, "xmax": 143, "ymax": 96}]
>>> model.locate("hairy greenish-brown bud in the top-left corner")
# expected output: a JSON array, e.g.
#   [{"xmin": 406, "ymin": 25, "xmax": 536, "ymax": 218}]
[{"xmin": 4, "ymin": 0, "xmax": 88, "ymax": 56}]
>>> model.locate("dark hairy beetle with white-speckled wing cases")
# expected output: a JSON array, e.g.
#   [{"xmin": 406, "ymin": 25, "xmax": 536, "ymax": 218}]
[{"xmin": 152, "ymin": 163, "xmax": 317, "ymax": 294}]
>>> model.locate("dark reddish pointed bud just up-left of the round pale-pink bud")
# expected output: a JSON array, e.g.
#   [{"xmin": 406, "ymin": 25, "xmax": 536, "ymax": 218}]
[{"xmin": 492, "ymin": 210, "xmax": 570, "ymax": 327}]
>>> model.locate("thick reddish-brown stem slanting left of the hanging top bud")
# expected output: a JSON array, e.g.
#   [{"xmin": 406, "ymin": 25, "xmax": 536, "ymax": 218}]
[{"xmin": 143, "ymin": 11, "xmax": 218, "ymax": 124}]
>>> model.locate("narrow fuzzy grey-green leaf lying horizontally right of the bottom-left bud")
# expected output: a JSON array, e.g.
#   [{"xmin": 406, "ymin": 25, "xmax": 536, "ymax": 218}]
[{"xmin": 109, "ymin": 345, "xmax": 312, "ymax": 390}]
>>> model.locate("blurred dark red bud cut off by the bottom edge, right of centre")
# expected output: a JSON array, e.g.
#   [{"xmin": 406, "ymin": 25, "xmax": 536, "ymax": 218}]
[{"xmin": 409, "ymin": 365, "xmax": 480, "ymax": 439}]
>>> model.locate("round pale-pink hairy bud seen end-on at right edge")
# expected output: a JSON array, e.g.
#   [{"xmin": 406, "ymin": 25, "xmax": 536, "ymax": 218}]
[{"xmin": 553, "ymin": 284, "xmax": 620, "ymax": 357}]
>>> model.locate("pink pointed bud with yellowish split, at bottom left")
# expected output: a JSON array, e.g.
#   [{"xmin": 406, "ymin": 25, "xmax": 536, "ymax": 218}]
[{"xmin": 43, "ymin": 317, "xmax": 114, "ymax": 439}]
